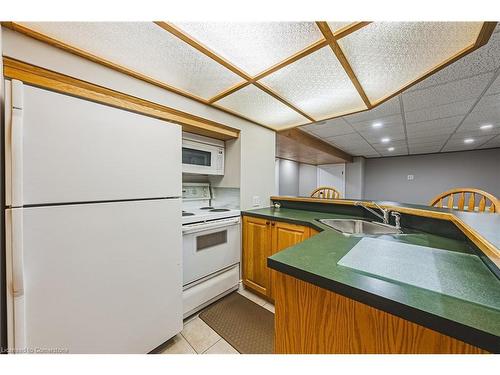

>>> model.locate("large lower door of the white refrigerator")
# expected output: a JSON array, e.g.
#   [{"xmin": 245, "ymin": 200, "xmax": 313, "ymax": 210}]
[{"xmin": 7, "ymin": 199, "xmax": 182, "ymax": 353}]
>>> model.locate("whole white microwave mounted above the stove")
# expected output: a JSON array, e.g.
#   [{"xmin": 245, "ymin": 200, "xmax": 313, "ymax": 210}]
[{"xmin": 182, "ymin": 132, "xmax": 224, "ymax": 176}]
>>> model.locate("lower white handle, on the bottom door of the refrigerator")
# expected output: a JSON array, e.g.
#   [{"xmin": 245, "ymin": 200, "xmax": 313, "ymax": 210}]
[{"xmin": 11, "ymin": 209, "xmax": 24, "ymax": 297}]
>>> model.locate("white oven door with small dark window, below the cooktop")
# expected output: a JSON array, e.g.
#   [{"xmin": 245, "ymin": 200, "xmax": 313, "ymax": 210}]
[{"xmin": 182, "ymin": 217, "xmax": 241, "ymax": 285}]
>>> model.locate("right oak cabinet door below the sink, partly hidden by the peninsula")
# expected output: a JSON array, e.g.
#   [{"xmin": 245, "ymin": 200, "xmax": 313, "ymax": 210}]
[{"xmin": 267, "ymin": 221, "xmax": 310, "ymax": 300}]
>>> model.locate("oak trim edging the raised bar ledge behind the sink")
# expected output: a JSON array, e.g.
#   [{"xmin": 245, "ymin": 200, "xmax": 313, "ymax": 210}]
[{"xmin": 270, "ymin": 196, "xmax": 500, "ymax": 268}]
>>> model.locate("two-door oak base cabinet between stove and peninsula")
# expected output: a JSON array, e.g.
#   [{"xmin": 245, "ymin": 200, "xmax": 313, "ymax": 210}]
[{"xmin": 242, "ymin": 216, "xmax": 318, "ymax": 300}]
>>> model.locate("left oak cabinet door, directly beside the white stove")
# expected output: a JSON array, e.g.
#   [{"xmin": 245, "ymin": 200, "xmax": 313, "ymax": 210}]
[{"xmin": 243, "ymin": 216, "xmax": 272, "ymax": 295}]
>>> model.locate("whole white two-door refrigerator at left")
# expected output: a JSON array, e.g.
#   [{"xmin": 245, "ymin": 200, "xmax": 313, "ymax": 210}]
[{"xmin": 5, "ymin": 80, "xmax": 182, "ymax": 353}]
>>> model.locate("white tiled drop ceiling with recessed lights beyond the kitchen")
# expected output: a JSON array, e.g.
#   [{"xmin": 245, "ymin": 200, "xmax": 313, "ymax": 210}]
[{"xmin": 301, "ymin": 26, "xmax": 500, "ymax": 158}]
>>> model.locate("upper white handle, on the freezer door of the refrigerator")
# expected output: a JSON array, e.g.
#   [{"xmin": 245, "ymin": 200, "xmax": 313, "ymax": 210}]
[{"xmin": 11, "ymin": 80, "xmax": 24, "ymax": 207}]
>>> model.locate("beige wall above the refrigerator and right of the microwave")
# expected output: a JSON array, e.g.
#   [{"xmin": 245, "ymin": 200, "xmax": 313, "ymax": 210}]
[{"xmin": 2, "ymin": 28, "xmax": 275, "ymax": 209}]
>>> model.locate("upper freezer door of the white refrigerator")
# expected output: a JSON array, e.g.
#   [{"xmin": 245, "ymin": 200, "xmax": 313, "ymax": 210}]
[{"xmin": 6, "ymin": 80, "xmax": 182, "ymax": 207}]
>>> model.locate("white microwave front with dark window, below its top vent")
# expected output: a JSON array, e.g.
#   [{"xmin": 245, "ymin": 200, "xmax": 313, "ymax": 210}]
[{"xmin": 182, "ymin": 139, "xmax": 224, "ymax": 175}]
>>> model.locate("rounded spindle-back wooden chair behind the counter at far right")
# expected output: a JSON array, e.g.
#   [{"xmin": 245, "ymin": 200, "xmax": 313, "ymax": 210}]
[{"xmin": 430, "ymin": 188, "xmax": 500, "ymax": 212}]
